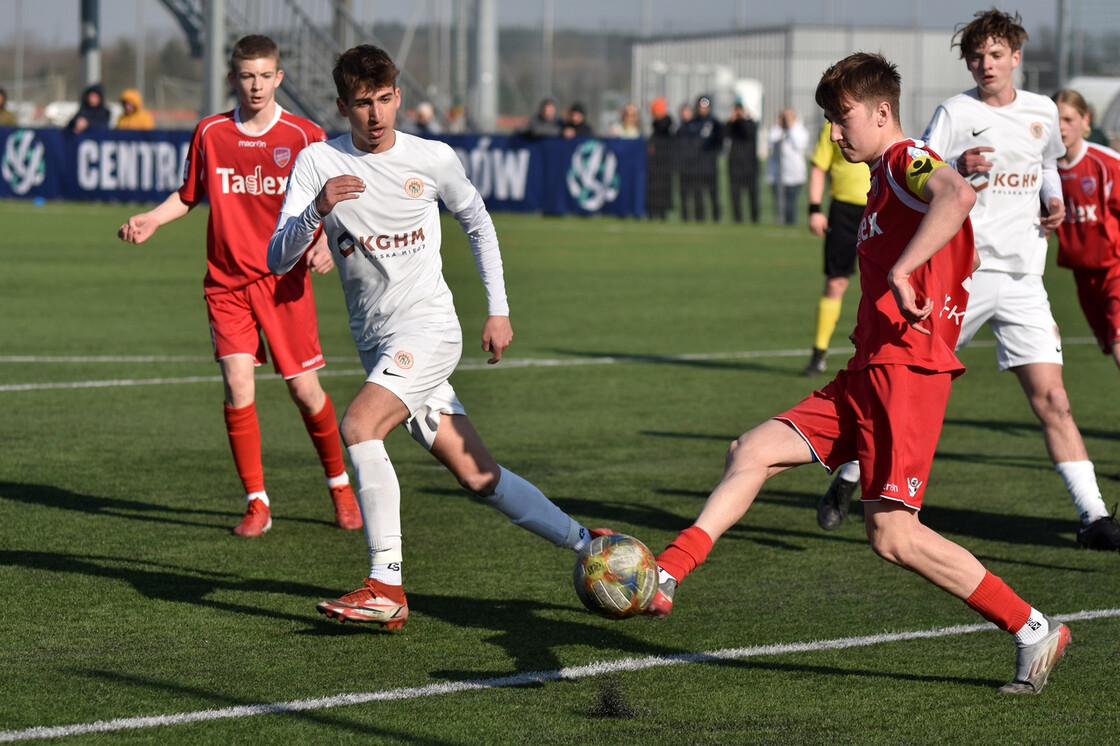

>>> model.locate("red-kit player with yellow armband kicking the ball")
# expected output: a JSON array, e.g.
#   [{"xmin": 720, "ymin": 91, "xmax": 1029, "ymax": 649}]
[{"xmin": 647, "ymin": 53, "xmax": 1070, "ymax": 693}]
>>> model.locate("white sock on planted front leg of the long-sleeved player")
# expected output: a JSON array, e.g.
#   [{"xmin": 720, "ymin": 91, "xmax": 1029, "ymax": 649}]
[{"xmin": 346, "ymin": 440, "xmax": 402, "ymax": 569}]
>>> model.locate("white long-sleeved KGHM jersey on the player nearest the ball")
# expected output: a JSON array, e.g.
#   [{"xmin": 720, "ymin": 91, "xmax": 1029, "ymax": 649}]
[{"xmin": 269, "ymin": 132, "xmax": 508, "ymax": 349}]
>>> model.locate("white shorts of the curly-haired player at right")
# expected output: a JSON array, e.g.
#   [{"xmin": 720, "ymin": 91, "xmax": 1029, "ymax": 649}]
[{"xmin": 956, "ymin": 270, "xmax": 1062, "ymax": 371}]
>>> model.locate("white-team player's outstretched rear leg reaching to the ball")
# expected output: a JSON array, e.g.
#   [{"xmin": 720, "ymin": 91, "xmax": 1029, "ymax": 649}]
[{"xmin": 421, "ymin": 408, "xmax": 590, "ymax": 551}]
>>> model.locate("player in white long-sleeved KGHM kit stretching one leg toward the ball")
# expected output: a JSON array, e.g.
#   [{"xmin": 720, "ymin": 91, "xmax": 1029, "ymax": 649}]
[{"xmin": 269, "ymin": 45, "xmax": 605, "ymax": 628}]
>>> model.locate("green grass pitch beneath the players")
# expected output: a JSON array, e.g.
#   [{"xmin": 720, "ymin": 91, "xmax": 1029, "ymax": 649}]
[{"xmin": 0, "ymin": 203, "xmax": 1120, "ymax": 745}]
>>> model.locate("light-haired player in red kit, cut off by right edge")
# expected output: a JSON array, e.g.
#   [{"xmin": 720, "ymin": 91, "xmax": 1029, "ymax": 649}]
[{"xmin": 1054, "ymin": 88, "xmax": 1120, "ymax": 378}]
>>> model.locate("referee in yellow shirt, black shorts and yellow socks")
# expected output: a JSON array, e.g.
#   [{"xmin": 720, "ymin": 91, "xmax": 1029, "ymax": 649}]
[{"xmin": 805, "ymin": 121, "xmax": 871, "ymax": 375}]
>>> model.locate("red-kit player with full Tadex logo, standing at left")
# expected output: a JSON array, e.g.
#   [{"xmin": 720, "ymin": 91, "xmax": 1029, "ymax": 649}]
[{"xmin": 118, "ymin": 36, "xmax": 362, "ymax": 537}]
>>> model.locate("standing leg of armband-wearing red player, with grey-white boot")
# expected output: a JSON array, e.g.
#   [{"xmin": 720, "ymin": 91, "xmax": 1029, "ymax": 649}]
[{"xmin": 865, "ymin": 501, "xmax": 1071, "ymax": 693}]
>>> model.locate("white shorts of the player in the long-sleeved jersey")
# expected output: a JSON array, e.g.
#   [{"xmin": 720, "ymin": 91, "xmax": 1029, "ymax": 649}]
[{"xmin": 357, "ymin": 325, "xmax": 467, "ymax": 450}]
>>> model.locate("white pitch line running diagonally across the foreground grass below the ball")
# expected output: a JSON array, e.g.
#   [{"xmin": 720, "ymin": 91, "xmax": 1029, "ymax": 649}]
[{"xmin": 0, "ymin": 608, "xmax": 1120, "ymax": 744}]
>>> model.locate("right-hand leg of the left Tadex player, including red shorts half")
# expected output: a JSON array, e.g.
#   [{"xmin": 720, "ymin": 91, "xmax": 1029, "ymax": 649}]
[{"xmin": 254, "ymin": 272, "xmax": 362, "ymax": 529}]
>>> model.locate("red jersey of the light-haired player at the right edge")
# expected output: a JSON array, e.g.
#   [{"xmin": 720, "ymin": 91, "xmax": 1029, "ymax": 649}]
[{"xmin": 1057, "ymin": 142, "xmax": 1120, "ymax": 269}]
